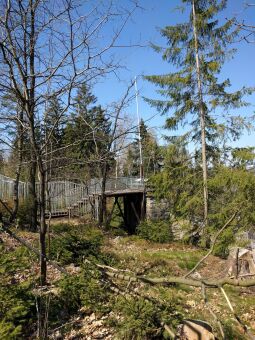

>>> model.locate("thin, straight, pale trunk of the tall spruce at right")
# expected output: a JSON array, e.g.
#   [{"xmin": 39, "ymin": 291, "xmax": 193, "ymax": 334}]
[{"xmin": 192, "ymin": 0, "xmax": 208, "ymax": 231}]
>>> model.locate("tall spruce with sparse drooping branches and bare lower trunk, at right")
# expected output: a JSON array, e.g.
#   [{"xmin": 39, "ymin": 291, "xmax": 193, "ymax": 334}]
[{"xmin": 146, "ymin": 0, "xmax": 250, "ymax": 230}]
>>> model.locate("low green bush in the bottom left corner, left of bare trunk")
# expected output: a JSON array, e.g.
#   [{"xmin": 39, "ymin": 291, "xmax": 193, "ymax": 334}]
[{"xmin": 0, "ymin": 245, "xmax": 36, "ymax": 340}]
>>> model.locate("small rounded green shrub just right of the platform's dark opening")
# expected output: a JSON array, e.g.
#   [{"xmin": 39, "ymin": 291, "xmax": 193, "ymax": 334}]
[{"xmin": 137, "ymin": 221, "xmax": 173, "ymax": 243}]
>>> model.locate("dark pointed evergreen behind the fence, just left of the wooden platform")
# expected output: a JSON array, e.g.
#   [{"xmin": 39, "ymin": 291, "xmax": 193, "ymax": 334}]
[{"xmin": 64, "ymin": 84, "xmax": 111, "ymax": 178}]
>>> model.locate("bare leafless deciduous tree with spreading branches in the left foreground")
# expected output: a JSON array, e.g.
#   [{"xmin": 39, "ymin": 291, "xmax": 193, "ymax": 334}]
[{"xmin": 0, "ymin": 0, "xmax": 137, "ymax": 285}]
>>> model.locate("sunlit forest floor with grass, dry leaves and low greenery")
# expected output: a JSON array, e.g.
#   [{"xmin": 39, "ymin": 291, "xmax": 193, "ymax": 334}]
[{"xmin": 0, "ymin": 224, "xmax": 255, "ymax": 340}]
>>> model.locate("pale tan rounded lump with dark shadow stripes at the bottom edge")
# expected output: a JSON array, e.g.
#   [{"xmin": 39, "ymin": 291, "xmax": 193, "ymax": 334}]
[{"xmin": 179, "ymin": 319, "xmax": 215, "ymax": 340}]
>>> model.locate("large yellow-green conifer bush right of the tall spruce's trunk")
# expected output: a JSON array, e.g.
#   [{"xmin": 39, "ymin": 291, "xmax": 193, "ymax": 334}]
[{"xmin": 208, "ymin": 166, "xmax": 255, "ymax": 257}]
